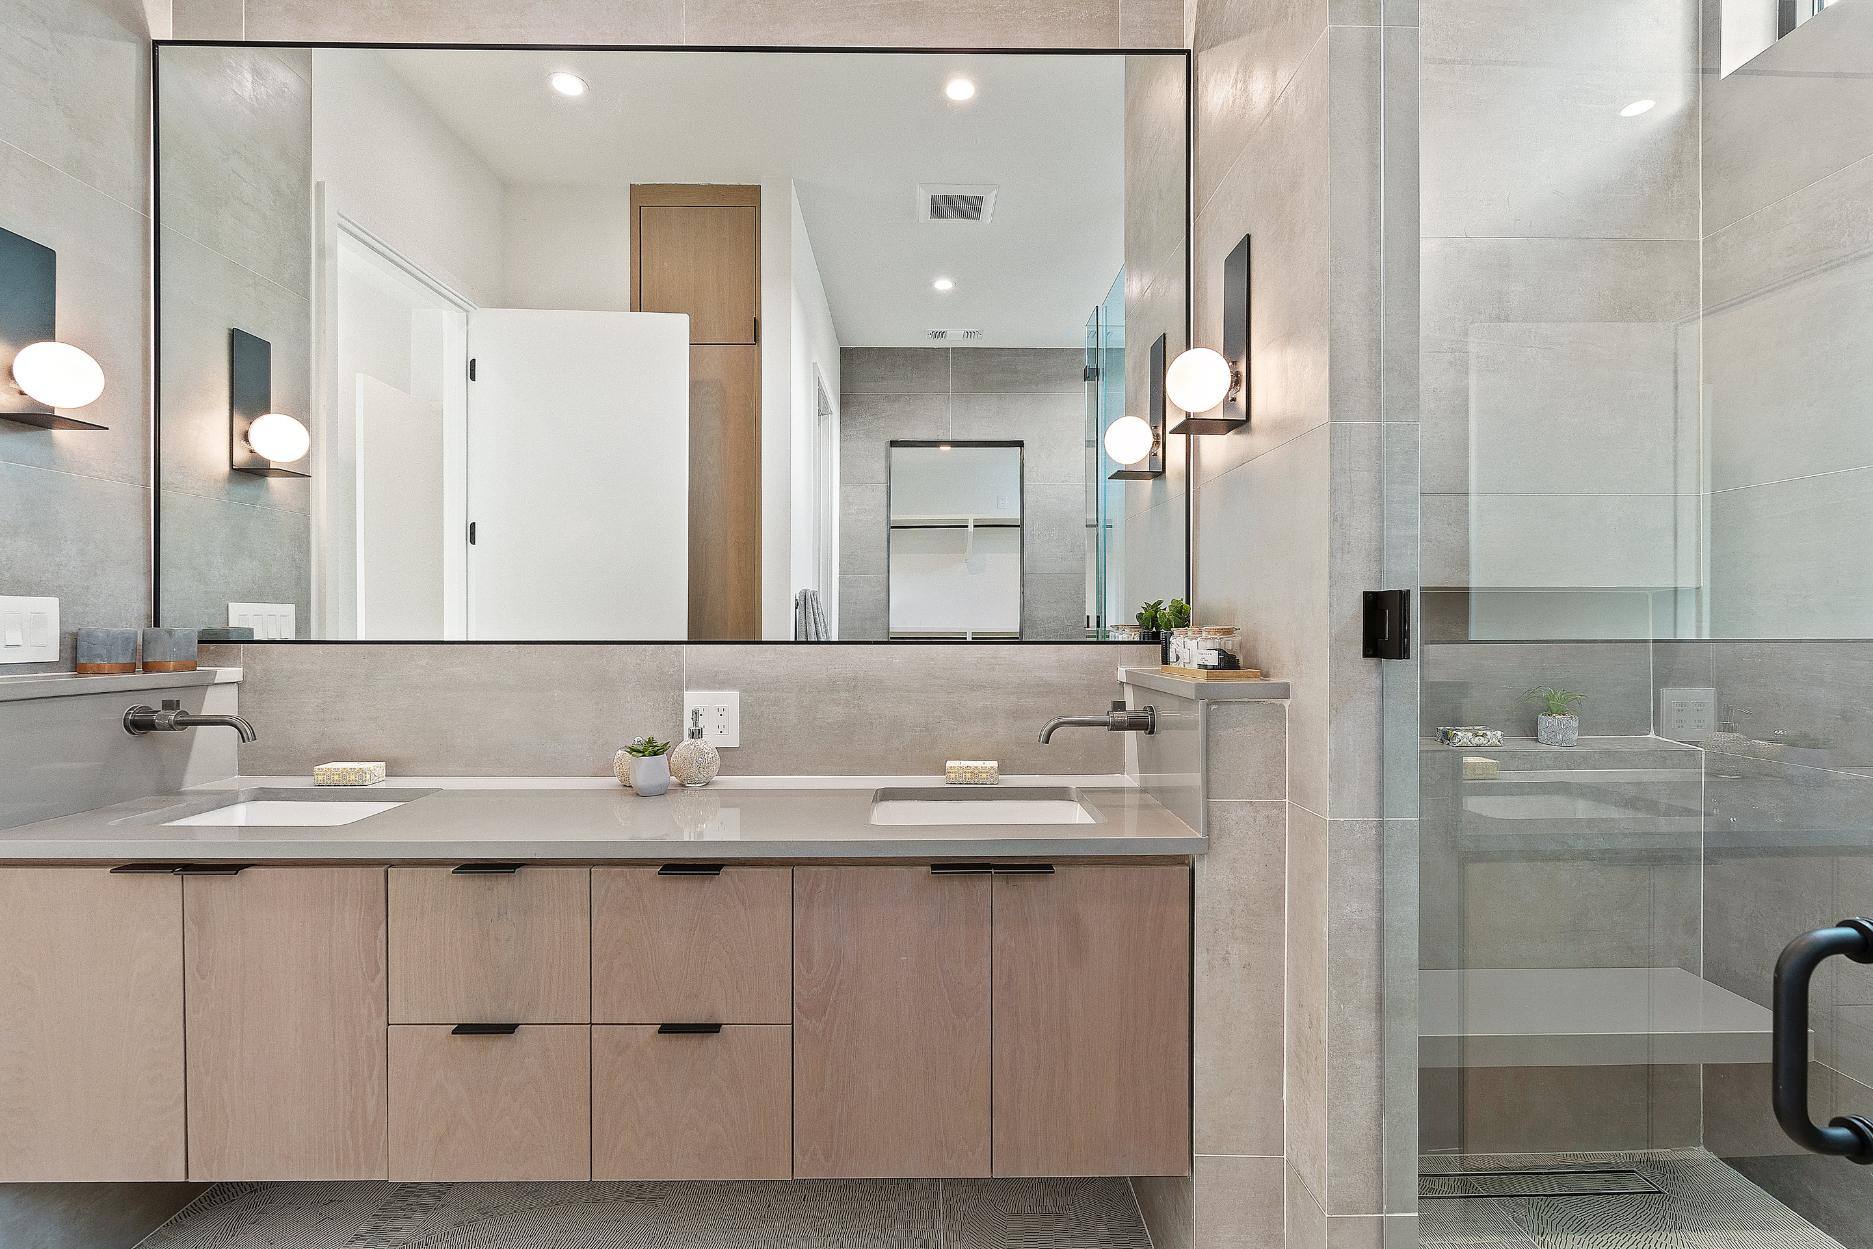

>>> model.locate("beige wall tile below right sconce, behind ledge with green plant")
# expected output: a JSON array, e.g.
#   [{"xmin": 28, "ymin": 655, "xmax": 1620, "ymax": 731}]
[{"xmin": 1195, "ymin": 425, "xmax": 1332, "ymax": 813}]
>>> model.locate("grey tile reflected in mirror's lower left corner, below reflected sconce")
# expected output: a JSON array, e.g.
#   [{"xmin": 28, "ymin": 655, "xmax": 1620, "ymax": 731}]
[{"xmin": 157, "ymin": 491, "xmax": 309, "ymax": 636}]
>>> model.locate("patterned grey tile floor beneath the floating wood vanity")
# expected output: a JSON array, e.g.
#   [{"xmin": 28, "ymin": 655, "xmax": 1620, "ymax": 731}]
[{"xmin": 139, "ymin": 1180, "xmax": 1150, "ymax": 1249}]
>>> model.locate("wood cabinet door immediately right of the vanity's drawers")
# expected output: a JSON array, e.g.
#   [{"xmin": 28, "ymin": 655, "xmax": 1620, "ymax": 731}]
[{"xmin": 794, "ymin": 867, "xmax": 989, "ymax": 1178}]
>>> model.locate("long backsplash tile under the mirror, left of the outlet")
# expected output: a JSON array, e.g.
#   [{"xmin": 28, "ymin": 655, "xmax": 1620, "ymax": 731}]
[{"xmin": 240, "ymin": 644, "xmax": 685, "ymax": 777}]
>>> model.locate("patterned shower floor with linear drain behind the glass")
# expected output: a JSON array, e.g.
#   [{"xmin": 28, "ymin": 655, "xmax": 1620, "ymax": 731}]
[{"xmin": 1418, "ymin": 1150, "xmax": 1841, "ymax": 1249}]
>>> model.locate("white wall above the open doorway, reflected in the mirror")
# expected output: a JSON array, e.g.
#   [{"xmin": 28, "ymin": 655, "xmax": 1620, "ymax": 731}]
[{"xmin": 313, "ymin": 51, "xmax": 506, "ymax": 307}]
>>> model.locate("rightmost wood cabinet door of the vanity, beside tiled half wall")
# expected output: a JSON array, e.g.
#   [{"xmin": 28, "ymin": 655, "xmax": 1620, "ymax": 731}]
[{"xmin": 995, "ymin": 865, "xmax": 1191, "ymax": 1176}]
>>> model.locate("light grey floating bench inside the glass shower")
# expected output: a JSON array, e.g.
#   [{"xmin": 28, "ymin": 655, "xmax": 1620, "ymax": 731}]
[{"xmin": 1418, "ymin": 966, "xmax": 1770, "ymax": 1067}]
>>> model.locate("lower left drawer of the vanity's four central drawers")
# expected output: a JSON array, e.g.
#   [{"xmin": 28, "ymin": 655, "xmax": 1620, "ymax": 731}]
[{"xmin": 390, "ymin": 1024, "xmax": 592, "ymax": 1182}]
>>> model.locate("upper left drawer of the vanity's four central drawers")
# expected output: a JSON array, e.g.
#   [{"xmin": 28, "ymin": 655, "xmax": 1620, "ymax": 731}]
[{"xmin": 390, "ymin": 867, "xmax": 592, "ymax": 1024}]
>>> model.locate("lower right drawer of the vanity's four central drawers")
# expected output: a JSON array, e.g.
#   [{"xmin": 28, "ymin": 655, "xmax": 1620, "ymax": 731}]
[{"xmin": 592, "ymin": 1024, "xmax": 792, "ymax": 1180}]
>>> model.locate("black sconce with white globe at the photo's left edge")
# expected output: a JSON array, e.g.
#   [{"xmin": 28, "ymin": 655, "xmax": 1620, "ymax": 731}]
[{"xmin": 0, "ymin": 230, "xmax": 105, "ymax": 429}]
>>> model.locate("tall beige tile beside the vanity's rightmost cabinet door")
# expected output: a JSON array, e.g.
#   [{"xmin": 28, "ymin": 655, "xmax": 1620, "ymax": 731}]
[{"xmin": 1191, "ymin": 801, "xmax": 1287, "ymax": 1155}]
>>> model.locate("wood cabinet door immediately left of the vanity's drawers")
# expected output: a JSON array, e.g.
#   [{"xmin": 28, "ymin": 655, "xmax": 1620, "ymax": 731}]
[{"xmin": 182, "ymin": 867, "xmax": 386, "ymax": 1180}]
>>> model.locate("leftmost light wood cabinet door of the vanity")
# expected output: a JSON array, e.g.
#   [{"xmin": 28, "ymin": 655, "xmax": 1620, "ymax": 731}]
[{"xmin": 0, "ymin": 867, "xmax": 185, "ymax": 1182}]
